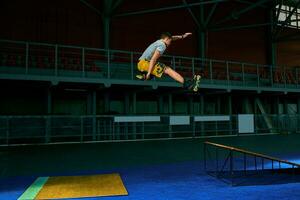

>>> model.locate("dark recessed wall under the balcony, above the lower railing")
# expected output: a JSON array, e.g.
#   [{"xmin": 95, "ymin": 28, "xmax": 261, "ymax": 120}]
[{"xmin": 0, "ymin": 81, "xmax": 300, "ymax": 115}]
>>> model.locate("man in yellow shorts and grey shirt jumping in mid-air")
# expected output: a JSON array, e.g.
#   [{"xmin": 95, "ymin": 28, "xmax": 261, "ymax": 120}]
[{"xmin": 136, "ymin": 32, "xmax": 201, "ymax": 92}]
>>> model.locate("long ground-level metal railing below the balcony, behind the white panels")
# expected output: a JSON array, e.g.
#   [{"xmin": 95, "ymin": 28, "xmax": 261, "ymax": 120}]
[{"xmin": 0, "ymin": 115, "xmax": 300, "ymax": 145}]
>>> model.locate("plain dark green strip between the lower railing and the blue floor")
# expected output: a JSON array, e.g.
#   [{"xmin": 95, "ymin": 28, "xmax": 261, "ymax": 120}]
[{"xmin": 0, "ymin": 134, "xmax": 300, "ymax": 177}]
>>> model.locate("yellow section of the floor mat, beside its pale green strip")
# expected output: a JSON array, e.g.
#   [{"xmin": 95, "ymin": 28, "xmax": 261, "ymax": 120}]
[{"xmin": 35, "ymin": 174, "xmax": 128, "ymax": 199}]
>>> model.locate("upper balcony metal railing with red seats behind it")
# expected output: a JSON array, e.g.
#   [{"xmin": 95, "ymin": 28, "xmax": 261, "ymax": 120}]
[{"xmin": 0, "ymin": 40, "xmax": 300, "ymax": 89}]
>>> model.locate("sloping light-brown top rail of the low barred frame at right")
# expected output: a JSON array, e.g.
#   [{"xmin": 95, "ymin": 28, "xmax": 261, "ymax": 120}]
[{"xmin": 204, "ymin": 141, "xmax": 300, "ymax": 168}]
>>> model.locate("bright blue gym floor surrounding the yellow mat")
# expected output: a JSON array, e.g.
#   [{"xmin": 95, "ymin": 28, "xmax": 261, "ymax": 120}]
[{"xmin": 0, "ymin": 159, "xmax": 300, "ymax": 200}]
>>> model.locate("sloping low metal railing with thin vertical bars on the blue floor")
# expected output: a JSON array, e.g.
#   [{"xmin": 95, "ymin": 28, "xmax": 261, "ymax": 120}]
[{"xmin": 203, "ymin": 142, "xmax": 300, "ymax": 185}]
